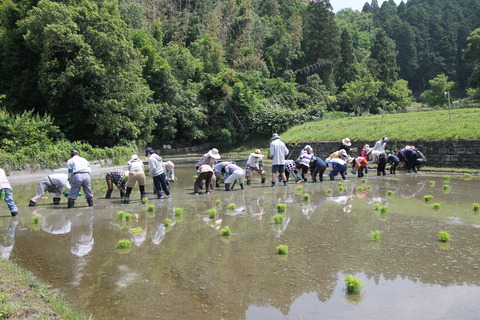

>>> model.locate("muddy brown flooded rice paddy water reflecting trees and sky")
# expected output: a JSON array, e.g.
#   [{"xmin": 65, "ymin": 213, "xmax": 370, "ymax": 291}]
[{"xmin": 0, "ymin": 166, "xmax": 480, "ymax": 319}]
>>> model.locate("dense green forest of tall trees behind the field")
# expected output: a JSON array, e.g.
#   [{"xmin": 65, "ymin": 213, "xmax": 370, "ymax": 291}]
[{"xmin": 0, "ymin": 0, "xmax": 480, "ymax": 150}]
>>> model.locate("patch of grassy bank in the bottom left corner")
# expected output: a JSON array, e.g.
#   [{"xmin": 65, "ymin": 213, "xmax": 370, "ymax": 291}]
[{"xmin": 0, "ymin": 260, "xmax": 88, "ymax": 320}]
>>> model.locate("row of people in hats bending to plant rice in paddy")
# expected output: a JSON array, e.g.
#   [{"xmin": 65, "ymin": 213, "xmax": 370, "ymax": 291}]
[{"xmin": 0, "ymin": 133, "xmax": 426, "ymax": 216}]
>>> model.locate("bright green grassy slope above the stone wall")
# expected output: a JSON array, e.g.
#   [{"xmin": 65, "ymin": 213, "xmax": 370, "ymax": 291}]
[{"xmin": 282, "ymin": 109, "xmax": 480, "ymax": 142}]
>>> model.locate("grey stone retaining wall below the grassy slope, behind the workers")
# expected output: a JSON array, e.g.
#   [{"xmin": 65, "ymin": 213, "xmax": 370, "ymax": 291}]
[{"xmin": 287, "ymin": 140, "xmax": 480, "ymax": 169}]
